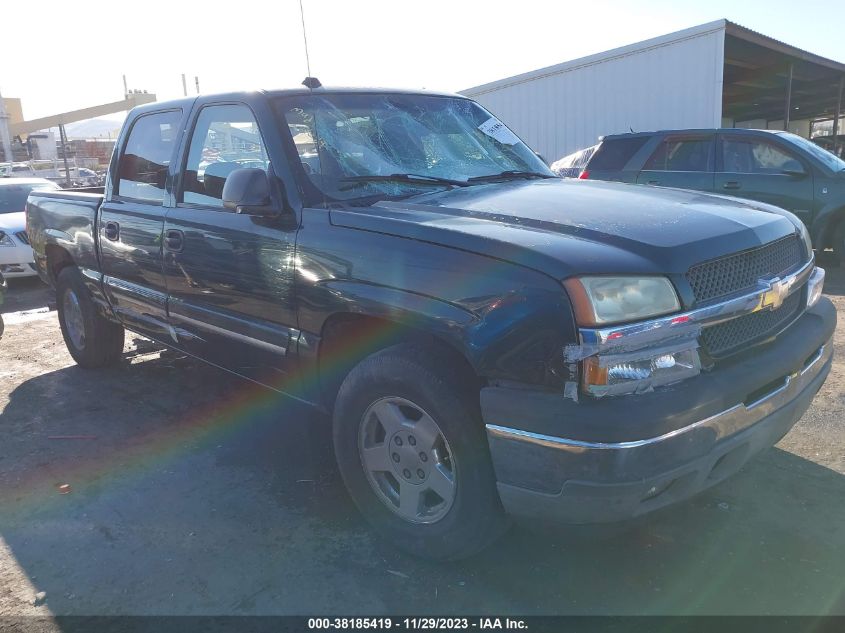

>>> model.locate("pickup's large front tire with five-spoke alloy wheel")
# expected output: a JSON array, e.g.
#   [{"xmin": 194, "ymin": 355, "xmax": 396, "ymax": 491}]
[{"xmin": 333, "ymin": 344, "xmax": 507, "ymax": 560}]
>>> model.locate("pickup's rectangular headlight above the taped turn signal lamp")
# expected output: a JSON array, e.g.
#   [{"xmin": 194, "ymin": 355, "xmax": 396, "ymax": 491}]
[{"xmin": 563, "ymin": 277, "xmax": 681, "ymax": 326}]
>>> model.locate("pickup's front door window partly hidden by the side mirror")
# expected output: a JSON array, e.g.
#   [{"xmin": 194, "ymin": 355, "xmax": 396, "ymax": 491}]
[{"xmin": 179, "ymin": 105, "xmax": 269, "ymax": 208}]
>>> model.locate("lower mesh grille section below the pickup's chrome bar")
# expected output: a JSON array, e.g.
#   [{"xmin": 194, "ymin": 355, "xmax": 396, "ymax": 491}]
[{"xmin": 701, "ymin": 289, "xmax": 804, "ymax": 358}]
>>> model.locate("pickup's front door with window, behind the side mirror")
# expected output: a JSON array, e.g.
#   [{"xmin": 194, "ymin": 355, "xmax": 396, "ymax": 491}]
[{"xmin": 164, "ymin": 103, "xmax": 298, "ymax": 391}]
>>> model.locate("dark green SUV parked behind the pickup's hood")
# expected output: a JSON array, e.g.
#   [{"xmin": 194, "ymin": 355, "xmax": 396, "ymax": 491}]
[{"xmin": 568, "ymin": 128, "xmax": 845, "ymax": 261}]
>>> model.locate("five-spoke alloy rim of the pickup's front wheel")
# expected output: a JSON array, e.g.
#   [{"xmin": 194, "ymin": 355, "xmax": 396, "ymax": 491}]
[{"xmin": 358, "ymin": 396, "xmax": 457, "ymax": 523}]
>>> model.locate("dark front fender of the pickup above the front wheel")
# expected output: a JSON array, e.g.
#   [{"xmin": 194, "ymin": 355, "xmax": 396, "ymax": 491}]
[{"xmin": 296, "ymin": 210, "xmax": 576, "ymax": 385}]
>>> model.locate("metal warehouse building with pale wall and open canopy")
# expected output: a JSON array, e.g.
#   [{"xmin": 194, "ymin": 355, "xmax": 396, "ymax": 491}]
[{"xmin": 462, "ymin": 20, "xmax": 845, "ymax": 162}]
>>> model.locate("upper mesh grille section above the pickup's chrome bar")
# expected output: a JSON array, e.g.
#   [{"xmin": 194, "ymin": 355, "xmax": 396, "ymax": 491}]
[{"xmin": 687, "ymin": 235, "xmax": 804, "ymax": 304}]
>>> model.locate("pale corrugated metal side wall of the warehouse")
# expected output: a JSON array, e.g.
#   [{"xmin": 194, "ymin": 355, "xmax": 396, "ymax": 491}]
[{"xmin": 463, "ymin": 27, "xmax": 725, "ymax": 162}]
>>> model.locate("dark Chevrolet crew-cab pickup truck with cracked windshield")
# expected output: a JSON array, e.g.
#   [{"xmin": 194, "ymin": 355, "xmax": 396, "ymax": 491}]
[{"xmin": 27, "ymin": 84, "xmax": 836, "ymax": 558}]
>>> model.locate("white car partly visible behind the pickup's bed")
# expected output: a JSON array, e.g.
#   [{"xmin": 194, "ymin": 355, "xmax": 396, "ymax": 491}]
[{"xmin": 0, "ymin": 178, "xmax": 59, "ymax": 279}]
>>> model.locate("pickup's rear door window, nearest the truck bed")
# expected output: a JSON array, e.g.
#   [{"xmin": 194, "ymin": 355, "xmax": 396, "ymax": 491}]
[{"xmin": 116, "ymin": 110, "xmax": 182, "ymax": 203}]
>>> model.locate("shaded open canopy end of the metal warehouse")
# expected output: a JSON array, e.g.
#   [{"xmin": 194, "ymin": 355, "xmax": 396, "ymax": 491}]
[{"xmin": 722, "ymin": 20, "xmax": 845, "ymax": 128}]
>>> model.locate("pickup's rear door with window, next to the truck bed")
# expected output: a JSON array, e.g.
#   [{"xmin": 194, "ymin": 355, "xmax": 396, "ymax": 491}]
[{"xmin": 97, "ymin": 109, "xmax": 182, "ymax": 340}]
